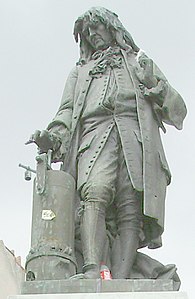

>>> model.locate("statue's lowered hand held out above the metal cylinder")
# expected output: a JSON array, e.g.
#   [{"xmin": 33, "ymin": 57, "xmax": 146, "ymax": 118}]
[{"xmin": 25, "ymin": 130, "xmax": 61, "ymax": 153}]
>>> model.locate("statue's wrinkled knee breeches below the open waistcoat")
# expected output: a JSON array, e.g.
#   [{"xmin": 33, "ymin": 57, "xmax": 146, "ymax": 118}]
[{"xmin": 78, "ymin": 127, "xmax": 143, "ymax": 233}]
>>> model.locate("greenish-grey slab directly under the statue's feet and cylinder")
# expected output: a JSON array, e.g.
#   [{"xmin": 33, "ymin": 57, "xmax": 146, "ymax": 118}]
[{"xmin": 22, "ymin": 279, "xmax": 177, "ymax": 294}]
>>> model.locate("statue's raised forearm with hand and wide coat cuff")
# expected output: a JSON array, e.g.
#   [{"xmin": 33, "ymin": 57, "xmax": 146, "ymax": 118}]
[{"xmin": 137, "ymin": 51, "xmax": 187, "ymax": 131}]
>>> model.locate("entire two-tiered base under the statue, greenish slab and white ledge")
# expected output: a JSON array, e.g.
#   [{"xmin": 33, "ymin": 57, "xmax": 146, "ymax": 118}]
[{"xmin": 8, "ymin": 279, "xmax": 188, "ymax": 299}]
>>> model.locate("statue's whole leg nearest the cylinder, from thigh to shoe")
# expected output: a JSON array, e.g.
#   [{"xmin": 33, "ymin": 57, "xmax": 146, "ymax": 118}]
[{"xmin": 78, "ymin": 126, "xmax": 118, "ymax": 278}]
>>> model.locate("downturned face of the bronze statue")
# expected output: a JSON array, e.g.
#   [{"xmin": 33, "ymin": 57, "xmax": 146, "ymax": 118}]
[{"xmin": 86, "ymin": 21, "xmax": 113, "ymax": 50}]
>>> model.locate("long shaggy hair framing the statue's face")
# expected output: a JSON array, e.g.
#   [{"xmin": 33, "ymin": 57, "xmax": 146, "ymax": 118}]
[{"xmin": 73, "ymin": 7, "xmax": 139, "ymax": 64}]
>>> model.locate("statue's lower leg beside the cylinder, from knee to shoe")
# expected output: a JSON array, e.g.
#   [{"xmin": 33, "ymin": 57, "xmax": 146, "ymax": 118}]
[{"xmin": 80, "ymin": 176, "xmax": 116, "ymax": 278}]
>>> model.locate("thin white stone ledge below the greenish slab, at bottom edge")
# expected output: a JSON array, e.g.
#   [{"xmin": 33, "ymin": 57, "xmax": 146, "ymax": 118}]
[{"xmin": 8, "ymin": 292, "xmax": 188, "ymax": 299}]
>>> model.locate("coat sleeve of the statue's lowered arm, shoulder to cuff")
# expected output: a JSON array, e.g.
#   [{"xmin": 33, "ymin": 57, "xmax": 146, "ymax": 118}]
[{"xmin": 47, "ymin": 67, "xmax": 78, "ymax": 130}]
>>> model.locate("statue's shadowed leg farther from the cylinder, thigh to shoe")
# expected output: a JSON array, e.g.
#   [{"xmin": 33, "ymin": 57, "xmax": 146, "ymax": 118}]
[{"xmin": 112, "ymin": 151, "xmax": 142, "ymax": 279}]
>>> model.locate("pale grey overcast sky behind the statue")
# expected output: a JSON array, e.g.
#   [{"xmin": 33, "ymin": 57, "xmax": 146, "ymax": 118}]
[{"xmin": 0, "ymin": 0, "xmax": 195, "ymax": 299}]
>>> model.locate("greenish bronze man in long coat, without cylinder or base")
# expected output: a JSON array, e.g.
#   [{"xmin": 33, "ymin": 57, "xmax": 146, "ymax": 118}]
[{"xmin": 30, "ymin": 7, "xmax": 186, "ymax": 278}]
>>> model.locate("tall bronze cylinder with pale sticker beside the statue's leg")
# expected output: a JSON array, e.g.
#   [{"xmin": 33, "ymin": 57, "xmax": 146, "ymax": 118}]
[{"xmin": 26, "ymin": 154, "xmax": 76, "ymax": 280}]
